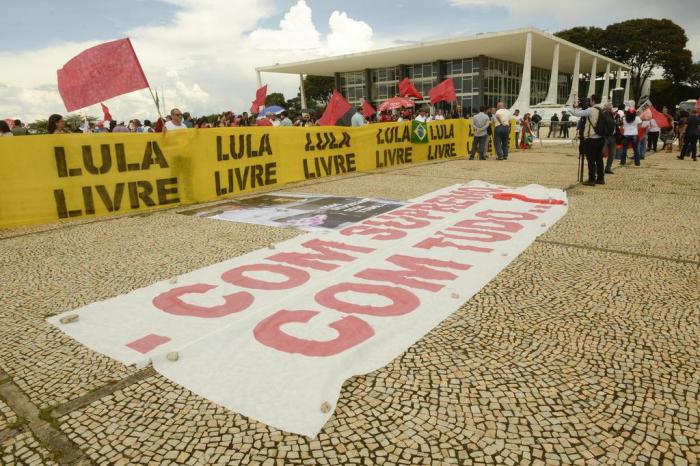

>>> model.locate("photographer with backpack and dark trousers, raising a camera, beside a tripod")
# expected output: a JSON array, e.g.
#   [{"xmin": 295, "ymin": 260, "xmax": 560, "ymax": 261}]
[{"xmin": 571, "ymin": 94, "xmax": 615, "ymax": 186}]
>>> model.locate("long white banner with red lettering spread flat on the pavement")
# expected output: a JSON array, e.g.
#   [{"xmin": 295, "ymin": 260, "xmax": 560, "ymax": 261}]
[{"xmin": 49, "ymin": 182, "xmax": 567, "ymax": 437}]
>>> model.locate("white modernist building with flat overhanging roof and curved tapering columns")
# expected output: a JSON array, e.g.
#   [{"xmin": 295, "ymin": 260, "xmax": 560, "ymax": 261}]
[{"xmin": 256, "ymin": 28, "xmax": 630, "ymax": 113}]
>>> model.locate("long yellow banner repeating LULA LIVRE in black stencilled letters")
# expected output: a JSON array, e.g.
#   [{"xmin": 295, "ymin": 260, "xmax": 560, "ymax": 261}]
[{"xmin": 0, "ymin": 120, "xmax": 512, "ymax": 227}]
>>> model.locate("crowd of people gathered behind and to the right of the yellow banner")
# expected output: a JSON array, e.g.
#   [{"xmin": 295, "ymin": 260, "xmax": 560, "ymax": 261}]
[{"xmin": 0, "ymin": 100, "xmax": 700, "ymax": 175}]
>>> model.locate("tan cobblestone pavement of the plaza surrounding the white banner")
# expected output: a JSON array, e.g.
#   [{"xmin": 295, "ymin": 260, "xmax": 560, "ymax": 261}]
[{"xmin": 0, "ymin": 146, "xmax": 700, "ymax": 465}]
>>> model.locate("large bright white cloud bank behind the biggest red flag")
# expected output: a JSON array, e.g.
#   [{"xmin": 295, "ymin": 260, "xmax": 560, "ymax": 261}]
[{"xmin": 0, "ymin": 0, "xmax": 380, "ymax": 121}]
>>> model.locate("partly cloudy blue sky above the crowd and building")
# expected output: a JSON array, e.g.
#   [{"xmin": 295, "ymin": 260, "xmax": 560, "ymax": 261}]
[{"xmin": 0, "ymin": 0, "xmax": 700, "ymax": 119}]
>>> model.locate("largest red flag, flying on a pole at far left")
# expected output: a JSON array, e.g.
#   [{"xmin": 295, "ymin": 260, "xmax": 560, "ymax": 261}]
[{"xmin": 56, "ymin": 38, "xmax": 149, "ymax": 112}]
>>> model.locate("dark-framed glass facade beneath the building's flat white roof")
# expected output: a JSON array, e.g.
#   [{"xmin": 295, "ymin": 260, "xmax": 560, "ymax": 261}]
[{"xmin": 336, "ymin": 56, "xmax": 571, "ymax": 113}]
